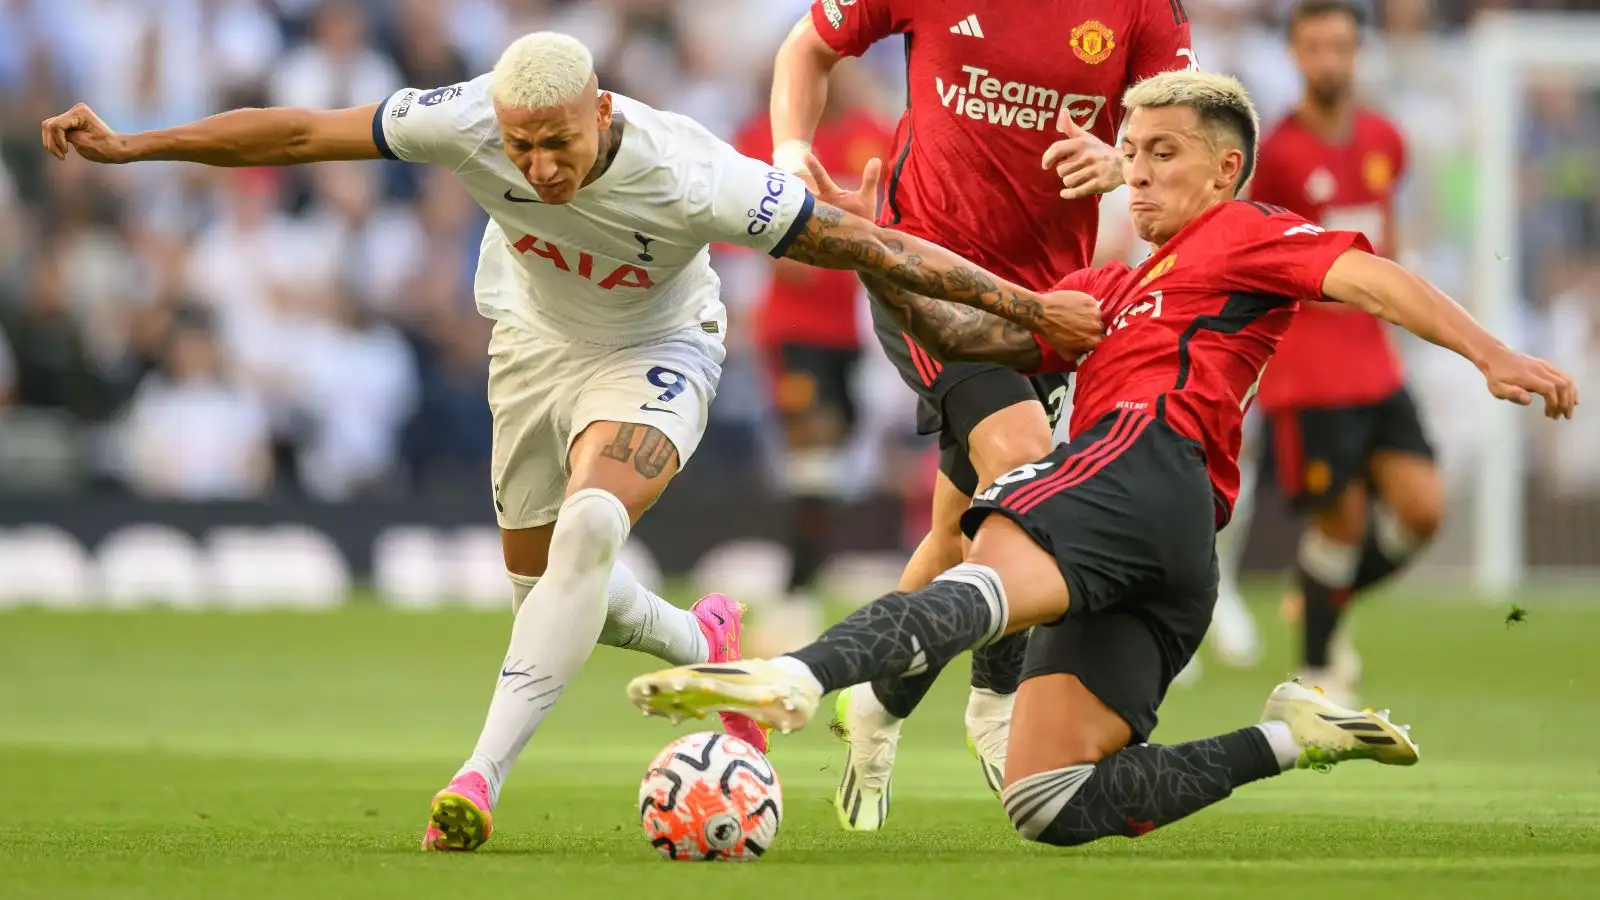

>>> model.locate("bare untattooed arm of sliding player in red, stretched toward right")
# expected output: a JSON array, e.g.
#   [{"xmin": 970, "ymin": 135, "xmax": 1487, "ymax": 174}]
[{"xmin": 1322, "ymin": 250, "xmax": 1578, "ymax": 418}]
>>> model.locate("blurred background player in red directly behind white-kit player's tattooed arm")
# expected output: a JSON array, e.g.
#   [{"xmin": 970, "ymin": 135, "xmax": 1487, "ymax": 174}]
[{"xmin": 733, "ymin": 64, "xmax": 894, "ymax": 652}]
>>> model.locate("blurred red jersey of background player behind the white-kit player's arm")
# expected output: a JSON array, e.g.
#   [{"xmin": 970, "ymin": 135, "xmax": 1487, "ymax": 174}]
[{"xmin": 733, "ymin": 110, "xmax": 893, "ymax": 349}]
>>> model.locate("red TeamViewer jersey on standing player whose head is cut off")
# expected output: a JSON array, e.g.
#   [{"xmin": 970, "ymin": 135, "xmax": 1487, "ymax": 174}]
[{"xmin": 811, "ymin": 0, "xmax": 1194, "ymax": 288}]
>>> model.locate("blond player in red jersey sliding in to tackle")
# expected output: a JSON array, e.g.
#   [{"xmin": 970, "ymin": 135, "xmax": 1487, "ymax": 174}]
[{"xmin": 629, "ymin": 72, "xmax": 1578, "ymax": 846}]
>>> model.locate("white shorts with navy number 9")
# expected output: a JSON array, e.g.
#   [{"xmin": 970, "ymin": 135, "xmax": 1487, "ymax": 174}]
[{"xmin": 490, "ymin": 322, "xmax": 726, "ymax": 528}]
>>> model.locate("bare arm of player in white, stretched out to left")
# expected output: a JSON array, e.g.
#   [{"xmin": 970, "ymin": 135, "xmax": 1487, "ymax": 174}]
[{"xmin": 40, "ymin": 102, "xmax": 381, "ymax": 167}]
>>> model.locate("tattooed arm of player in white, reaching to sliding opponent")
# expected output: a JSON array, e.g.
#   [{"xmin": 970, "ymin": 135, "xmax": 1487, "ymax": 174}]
[{"xmin": 784, "ymin": 202, "xmax": 1102, "ymax": 359}]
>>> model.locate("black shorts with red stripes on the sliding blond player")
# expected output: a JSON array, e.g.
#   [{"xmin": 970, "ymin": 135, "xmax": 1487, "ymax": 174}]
[{"xmin": 962, "ymin": 412, "xmax": 1218, "ymax": 743}]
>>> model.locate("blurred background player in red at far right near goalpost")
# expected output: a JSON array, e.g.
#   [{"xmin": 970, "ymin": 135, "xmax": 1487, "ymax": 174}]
[{"xmin": 1251, "ymin": 0, "xmax": 1443, "ymax": 706}]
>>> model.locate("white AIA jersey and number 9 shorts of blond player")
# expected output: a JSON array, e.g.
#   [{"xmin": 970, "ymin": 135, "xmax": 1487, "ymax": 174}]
[{"xmin": 373, "ymin": 75, "xmax": 813, "ymax": 528}]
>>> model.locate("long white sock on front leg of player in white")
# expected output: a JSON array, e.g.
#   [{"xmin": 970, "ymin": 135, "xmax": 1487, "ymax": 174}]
[{"xmin": 458, "ymin": 488, "xmax": 630, "ymax": 804}]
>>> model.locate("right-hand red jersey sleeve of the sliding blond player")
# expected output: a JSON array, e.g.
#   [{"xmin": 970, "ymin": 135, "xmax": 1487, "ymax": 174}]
[{"xmin": 1218, "ymin": 203, "xmax": 1373, "ymax": 299}]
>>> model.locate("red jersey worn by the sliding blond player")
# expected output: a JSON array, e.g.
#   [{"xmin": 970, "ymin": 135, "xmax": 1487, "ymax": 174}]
[{"xmin": 1040, "ymin": 200, "xmax": 1371, "ymax": 525}]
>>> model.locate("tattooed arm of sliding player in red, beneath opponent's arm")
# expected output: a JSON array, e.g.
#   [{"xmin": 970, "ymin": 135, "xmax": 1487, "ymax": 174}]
[{"xmin": 862, "ymin": 275, "xmax": 1042, "ymax": 372}]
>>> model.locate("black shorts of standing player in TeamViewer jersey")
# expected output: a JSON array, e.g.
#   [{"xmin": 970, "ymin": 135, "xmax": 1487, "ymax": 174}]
[{"xmin": 867, "ymin": 285, "xmax": 1072, "ymax": 496}]
